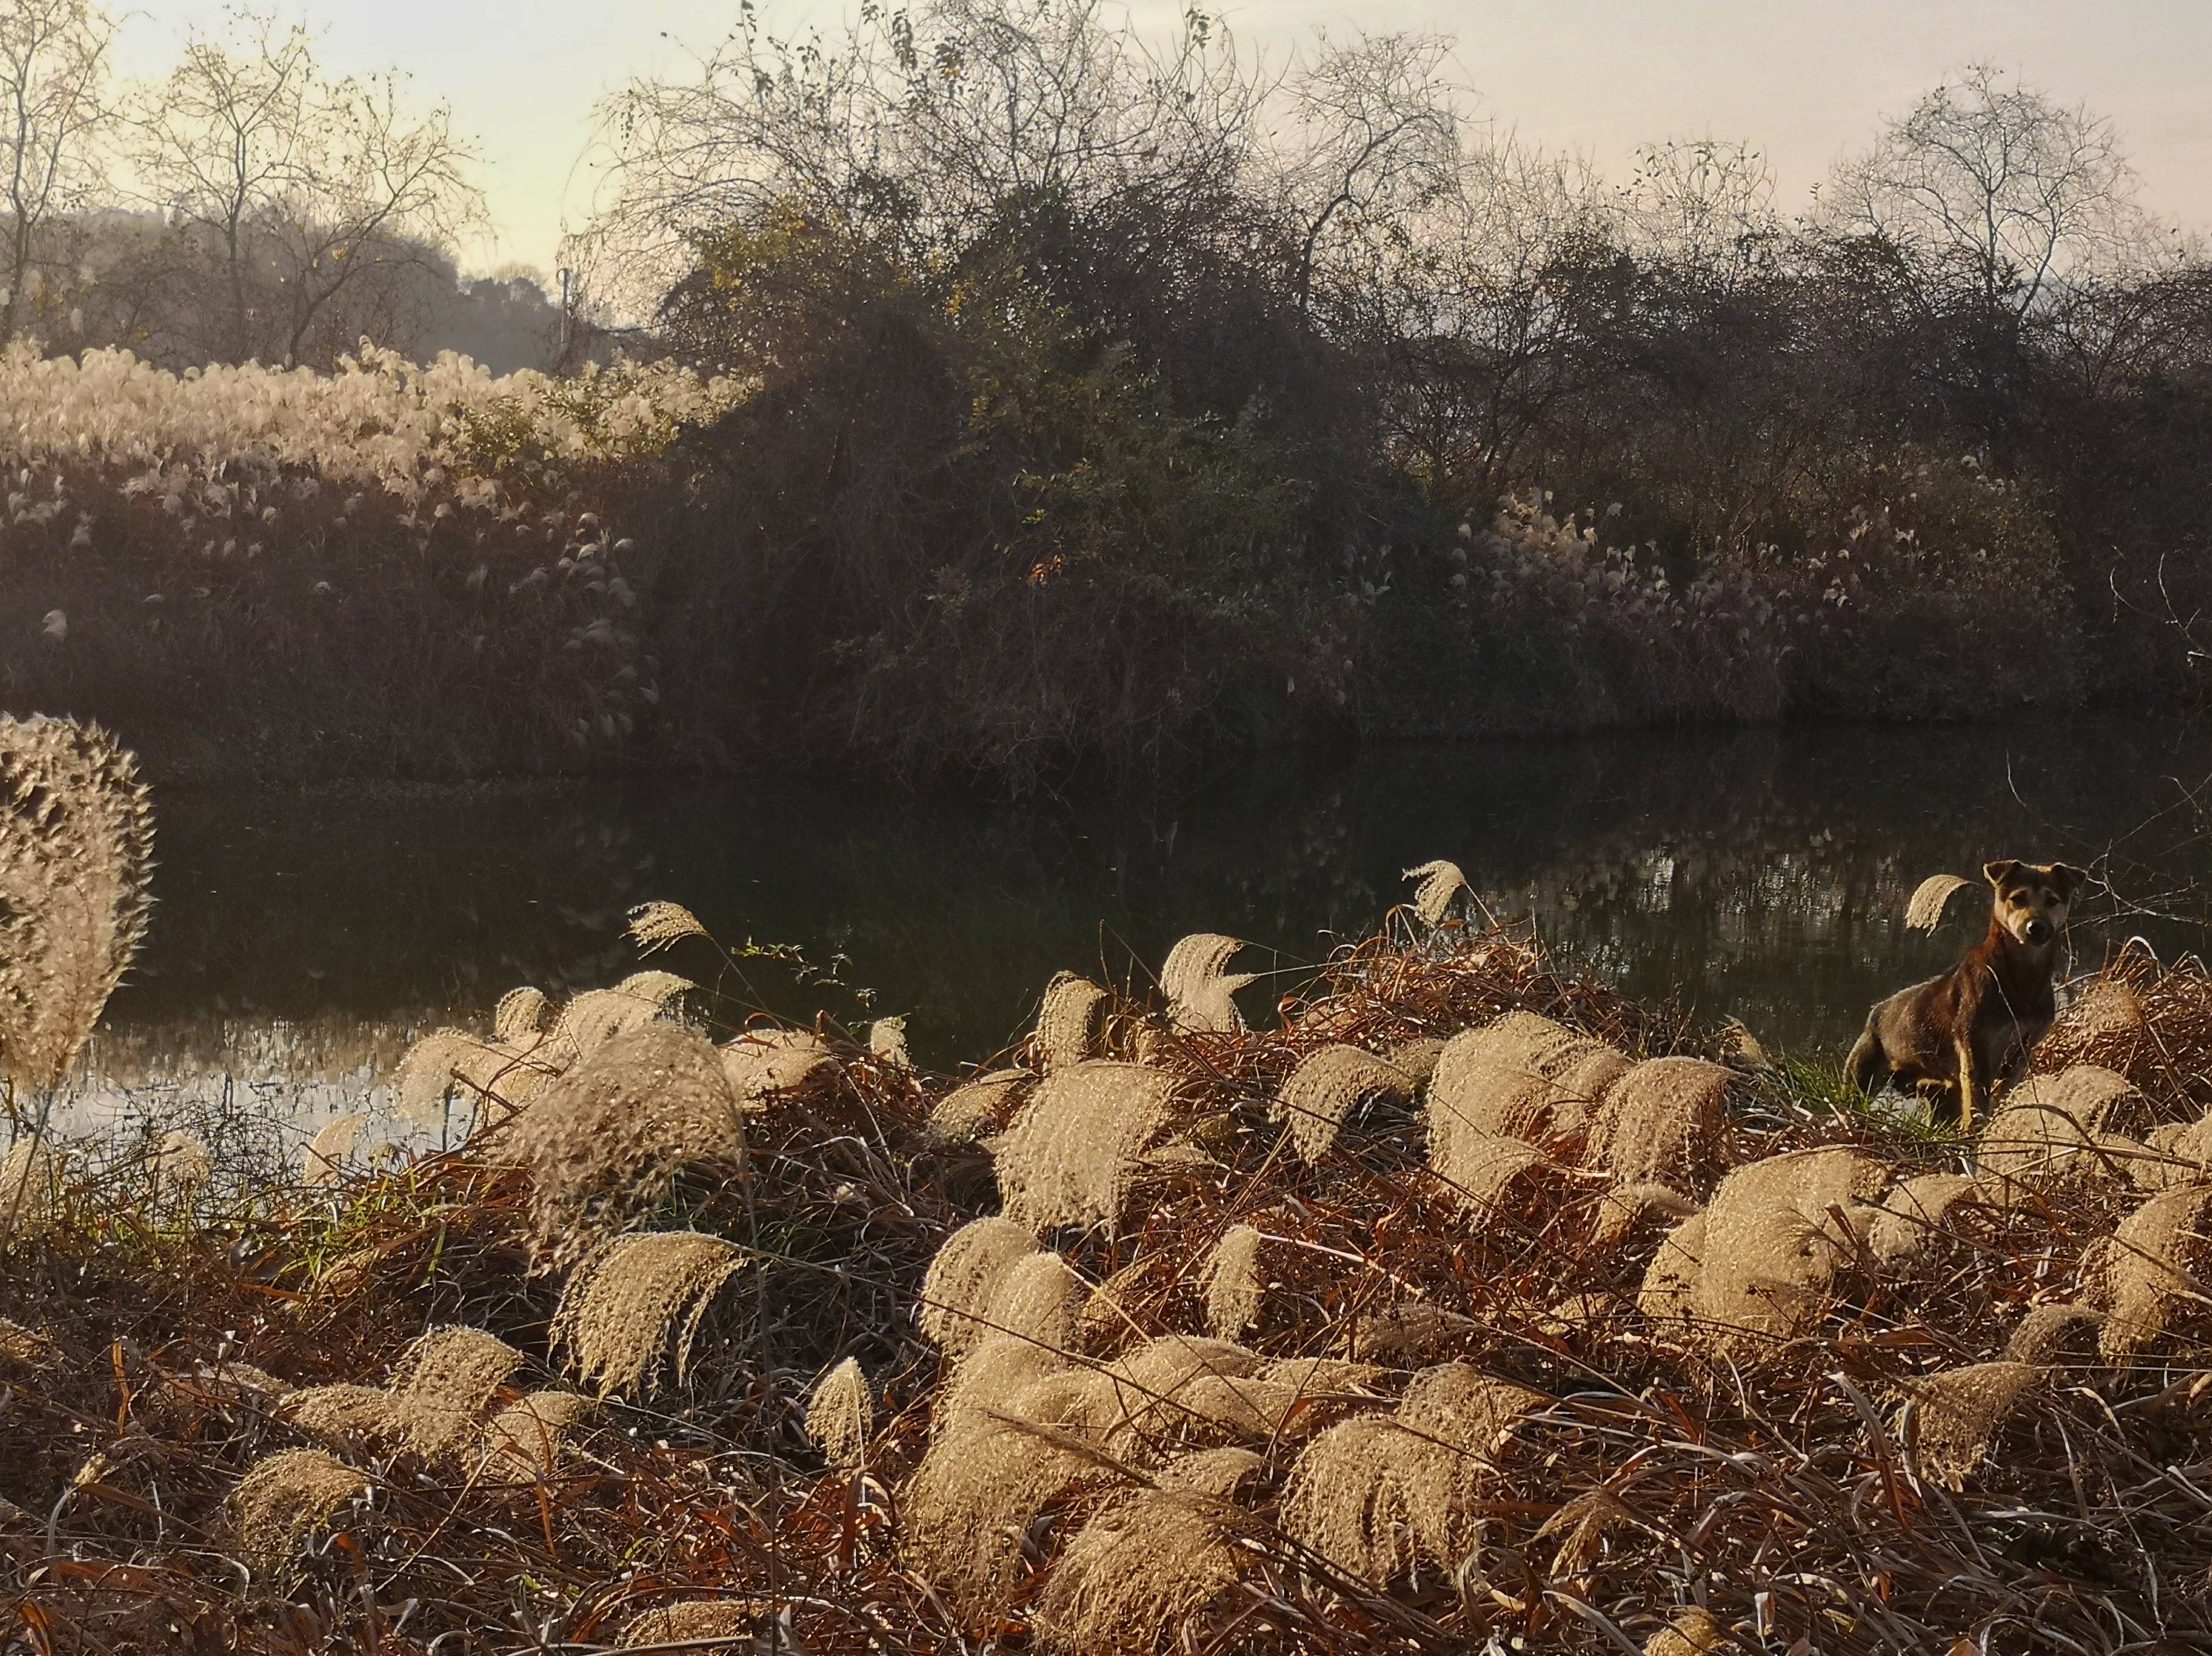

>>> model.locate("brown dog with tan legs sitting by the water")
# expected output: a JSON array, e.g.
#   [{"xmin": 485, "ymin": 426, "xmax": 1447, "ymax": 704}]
[{"xmin": 1842, "ymin": 862, "xmax": 2088, "ymax": 1132}]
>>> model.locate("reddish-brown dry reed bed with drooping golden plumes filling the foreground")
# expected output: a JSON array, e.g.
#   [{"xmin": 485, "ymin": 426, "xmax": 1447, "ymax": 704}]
[{"xmin": 13, "ymin": 911, "xmax": 2212, "ymax": 1651}]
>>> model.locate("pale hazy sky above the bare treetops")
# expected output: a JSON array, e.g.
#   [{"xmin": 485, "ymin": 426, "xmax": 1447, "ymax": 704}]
[{"xmin": 121, "ymin": 0, "xmax": 2212, "ymax": 270}]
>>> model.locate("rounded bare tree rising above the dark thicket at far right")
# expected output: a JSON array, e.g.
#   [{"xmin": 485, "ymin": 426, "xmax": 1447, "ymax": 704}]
[{"xmin": 1825, "ymin": 64, "xmax": 2148, "ymax": 318}]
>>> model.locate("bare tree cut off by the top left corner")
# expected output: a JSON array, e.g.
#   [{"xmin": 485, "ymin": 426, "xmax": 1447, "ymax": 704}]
[{"xmin": 0, "ymin": 0, "xmax": 115, "ymax": 341}]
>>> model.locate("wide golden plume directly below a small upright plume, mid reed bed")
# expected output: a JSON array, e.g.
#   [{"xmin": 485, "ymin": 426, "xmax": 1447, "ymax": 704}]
[{"xmin": 995, "ymin": 1059, "xmax": 1174, "ymax": 1234}]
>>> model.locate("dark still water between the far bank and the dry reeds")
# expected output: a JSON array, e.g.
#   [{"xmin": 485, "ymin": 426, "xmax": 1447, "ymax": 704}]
[{"xmin": 78, "ymin": 721, "xmax": 2212, "ymax": 1092}]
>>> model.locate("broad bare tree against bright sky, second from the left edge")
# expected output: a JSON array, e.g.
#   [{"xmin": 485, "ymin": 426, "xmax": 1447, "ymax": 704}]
[{"xmin": 133, "ymin": 14, "xmax": 482, "ymax": 363}]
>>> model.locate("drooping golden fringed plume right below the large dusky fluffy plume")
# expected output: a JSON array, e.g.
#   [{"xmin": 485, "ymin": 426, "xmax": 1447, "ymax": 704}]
[{"xmin": 551, "ymin": 1232, "xmax": 743, "ymax": 1397}]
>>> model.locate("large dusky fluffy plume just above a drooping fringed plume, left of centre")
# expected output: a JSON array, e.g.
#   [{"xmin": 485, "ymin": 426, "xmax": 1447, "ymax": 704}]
[{"xmin": 504, "ymin": 1023, "xmax": 745, "ymax": 1260}]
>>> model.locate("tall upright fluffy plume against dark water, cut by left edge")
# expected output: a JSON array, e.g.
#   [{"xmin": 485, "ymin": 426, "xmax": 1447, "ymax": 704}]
[{"xmin": 0, "ymin": 716, "xmax": 153, "ymax": 1090}]
